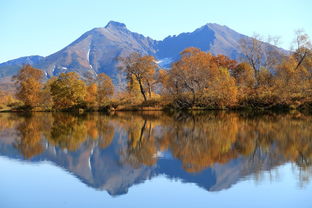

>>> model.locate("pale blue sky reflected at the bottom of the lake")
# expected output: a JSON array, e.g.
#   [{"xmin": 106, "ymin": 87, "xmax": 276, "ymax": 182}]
[{"xmin": 0, "ymin": 157, "xmax": 312, "ymax": 208}]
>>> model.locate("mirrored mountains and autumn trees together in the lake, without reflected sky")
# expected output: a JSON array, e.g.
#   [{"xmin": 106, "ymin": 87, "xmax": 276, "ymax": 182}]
[{"xmin": 0, "ymin": 114, "xmax": 312, "ymax": 195}]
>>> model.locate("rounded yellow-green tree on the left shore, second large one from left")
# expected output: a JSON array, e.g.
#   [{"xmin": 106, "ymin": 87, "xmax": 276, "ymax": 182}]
[{"xmin": 51, "ymin": 72, "xmax": 86, "ymax": 109}]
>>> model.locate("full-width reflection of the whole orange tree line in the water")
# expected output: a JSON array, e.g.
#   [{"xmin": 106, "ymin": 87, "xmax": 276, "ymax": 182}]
[{"xmin": 6, "ymin": 112, "xmax": 312, "ymax": 184}]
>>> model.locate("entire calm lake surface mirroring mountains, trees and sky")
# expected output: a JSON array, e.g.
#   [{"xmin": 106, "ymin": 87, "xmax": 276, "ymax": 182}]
[{"xmin": 0, "ymin": 112, "xmax": 312, "ymax": 208}]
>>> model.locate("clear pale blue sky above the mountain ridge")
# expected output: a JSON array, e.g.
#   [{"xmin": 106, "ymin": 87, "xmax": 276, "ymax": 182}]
[{"xmin": 0, "ymin": 0, "xmax": 312, "ymax": 62}]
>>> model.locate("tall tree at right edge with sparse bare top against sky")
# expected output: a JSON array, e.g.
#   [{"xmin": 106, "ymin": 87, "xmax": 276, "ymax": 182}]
[{"xmin": 275, "ymin": 30, "xmax": 312, "ymax": 106}]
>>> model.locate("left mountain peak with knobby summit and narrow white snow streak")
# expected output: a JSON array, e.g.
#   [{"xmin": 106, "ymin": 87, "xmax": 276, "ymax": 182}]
[{"xmin": 37, "ymin": 21, "xmax": 155, "ymax": 76}]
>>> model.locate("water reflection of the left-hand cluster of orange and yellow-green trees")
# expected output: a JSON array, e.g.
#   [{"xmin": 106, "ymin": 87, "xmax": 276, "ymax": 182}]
[{"xmin": 10, "ymin": 113, "xmax": 114, "ymax": 158}]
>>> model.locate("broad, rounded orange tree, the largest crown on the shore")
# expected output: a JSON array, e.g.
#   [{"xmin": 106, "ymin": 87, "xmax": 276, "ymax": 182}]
[{"xmin": 161, "ymin": 48, "xmax": 236, "ymax": 108}]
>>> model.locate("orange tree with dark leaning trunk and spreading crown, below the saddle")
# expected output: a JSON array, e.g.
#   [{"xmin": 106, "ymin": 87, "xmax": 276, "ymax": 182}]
[{"xmin": 119, "ymin": 53, "xmax": 157, "ymax": 101}]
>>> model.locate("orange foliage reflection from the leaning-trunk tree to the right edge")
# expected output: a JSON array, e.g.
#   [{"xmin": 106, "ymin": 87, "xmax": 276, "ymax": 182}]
[{"xmin": 114, "ymin": 112, "xmax": 312, "ymax": 184}]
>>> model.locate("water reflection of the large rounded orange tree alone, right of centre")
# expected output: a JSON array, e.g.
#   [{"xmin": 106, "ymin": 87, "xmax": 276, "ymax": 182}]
[{"xmin": 165, "ymin": 115, "xmax": 237, "ymax": 172}]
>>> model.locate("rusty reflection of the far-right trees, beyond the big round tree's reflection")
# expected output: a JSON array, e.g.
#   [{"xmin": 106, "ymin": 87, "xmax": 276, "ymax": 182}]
[{"xmin": 236, "ymin": 115, "xmax": 312, "ymax": 178}]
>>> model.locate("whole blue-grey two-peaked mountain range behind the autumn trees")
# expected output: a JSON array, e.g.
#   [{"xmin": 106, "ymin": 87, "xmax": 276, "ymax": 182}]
[{"xmin": 0, "ymin": 21, "xmax": 280, "ymax": 79}]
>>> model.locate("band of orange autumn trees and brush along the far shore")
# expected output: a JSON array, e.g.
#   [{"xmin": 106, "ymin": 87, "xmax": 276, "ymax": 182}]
[{"xmin": 0, "ymin": 31, "xmax": 312, "ymax": 113}]
